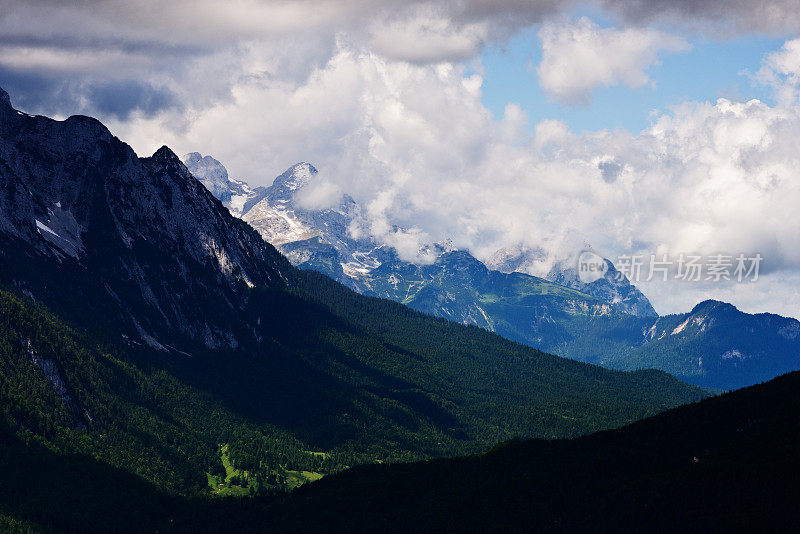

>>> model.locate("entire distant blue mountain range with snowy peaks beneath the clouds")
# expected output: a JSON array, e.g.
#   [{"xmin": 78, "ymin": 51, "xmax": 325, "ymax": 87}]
[{"xmin": 183, "ymin": 153, "xmax": 800, "ymax": 390}]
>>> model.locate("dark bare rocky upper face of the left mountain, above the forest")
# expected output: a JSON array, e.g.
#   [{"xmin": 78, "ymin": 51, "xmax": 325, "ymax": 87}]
[{"xmin": 0, "ymin": 93, "xmax": 288, "ymax": 348}]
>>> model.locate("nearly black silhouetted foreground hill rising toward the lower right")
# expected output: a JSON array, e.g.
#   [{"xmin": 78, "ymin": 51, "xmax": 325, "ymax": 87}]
[{"xmin": 260, "ymin": 373, "xmax": 800, "ymax": 532}]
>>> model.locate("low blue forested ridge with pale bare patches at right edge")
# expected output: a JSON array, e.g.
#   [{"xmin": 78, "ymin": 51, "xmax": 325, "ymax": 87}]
[{"xmin": 542, "ymin": 300, "xmax": 800, "ymax": 389}]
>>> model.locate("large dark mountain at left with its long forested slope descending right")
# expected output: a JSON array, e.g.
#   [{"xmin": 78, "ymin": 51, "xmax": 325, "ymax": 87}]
[{"xmin": 0, "ymin": 85, "xmax": 708, "ymax": 532}]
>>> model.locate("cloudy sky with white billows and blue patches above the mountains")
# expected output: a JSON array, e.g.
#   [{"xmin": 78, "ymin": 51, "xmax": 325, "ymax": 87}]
[{"xmin": 0, "ymin": 0, "xmax": 800, "ymax": 317}]
